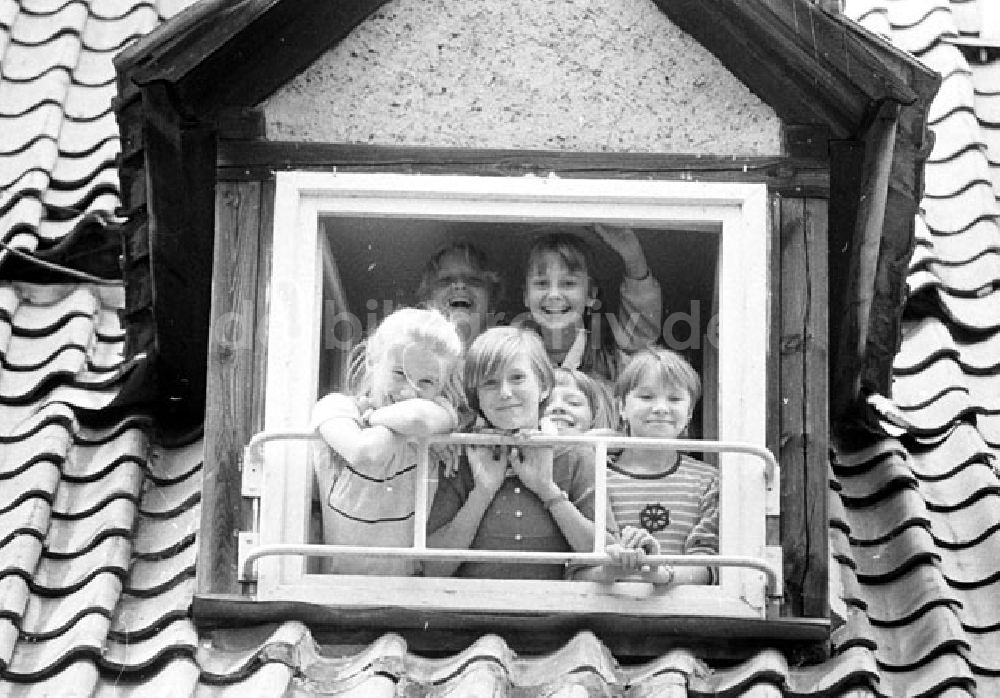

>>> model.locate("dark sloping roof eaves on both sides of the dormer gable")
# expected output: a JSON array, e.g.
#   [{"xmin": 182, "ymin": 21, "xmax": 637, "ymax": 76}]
[{"xmin": 115, "ymin": 0, "xmax": 936, "ymax": 138}]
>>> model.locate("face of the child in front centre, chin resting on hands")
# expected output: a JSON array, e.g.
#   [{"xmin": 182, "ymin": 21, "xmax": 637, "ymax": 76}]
[{"xmin": 476, "ymin": 355, "xmax": 545, "ymax": 429}]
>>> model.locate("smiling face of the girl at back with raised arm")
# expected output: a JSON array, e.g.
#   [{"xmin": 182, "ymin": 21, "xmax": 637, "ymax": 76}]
[{"xmin": 524, "ymin": 252, "xmax": 590, "ymax": 330}]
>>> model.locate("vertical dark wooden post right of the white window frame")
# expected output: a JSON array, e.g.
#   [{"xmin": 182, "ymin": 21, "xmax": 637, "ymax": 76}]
[{"xmin": 778, "ymin": 194, "xmax": 829, "ymax": 618}]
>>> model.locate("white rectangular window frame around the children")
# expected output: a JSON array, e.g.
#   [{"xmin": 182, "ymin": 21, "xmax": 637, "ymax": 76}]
[{"xmin": 256, "ymin": 172, "xmax": 780, "ymax": 619}]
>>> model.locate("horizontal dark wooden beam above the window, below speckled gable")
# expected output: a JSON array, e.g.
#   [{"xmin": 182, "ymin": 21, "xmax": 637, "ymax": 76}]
[{"xmin": 219, "ymin": 141, "xmax": 829, "ymax": 196}]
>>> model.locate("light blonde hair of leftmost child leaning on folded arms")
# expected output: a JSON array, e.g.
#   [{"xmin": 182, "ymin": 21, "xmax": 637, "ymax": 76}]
[{"xmin": 347, "ymin": 308, "xmax": 465, "ymax": 409}]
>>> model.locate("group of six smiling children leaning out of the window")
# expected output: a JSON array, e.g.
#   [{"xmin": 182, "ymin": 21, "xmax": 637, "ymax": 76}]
[{"xmin": 313, "ymin": 225, "xmax": 718, "ymax": 584}]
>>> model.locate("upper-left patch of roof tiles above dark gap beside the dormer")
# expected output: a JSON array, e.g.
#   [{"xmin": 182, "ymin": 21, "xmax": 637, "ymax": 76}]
[{"xmin": 0, "ymin": 0, "xmax": 193, "ymax": 249}]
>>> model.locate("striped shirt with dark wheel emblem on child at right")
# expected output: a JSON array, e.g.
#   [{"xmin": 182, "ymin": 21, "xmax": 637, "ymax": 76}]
[{"xmin": 608, "ymin": 455, "xmax": 719, "ymax": 555}]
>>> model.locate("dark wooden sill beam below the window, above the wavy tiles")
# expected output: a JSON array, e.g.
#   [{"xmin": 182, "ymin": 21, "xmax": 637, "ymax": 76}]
[{"xmin": 193, "ymin": 594, "xmax": 830, "ymax": 661}]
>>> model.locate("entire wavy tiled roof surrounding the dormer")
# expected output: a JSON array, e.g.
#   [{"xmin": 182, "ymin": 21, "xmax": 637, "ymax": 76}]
[{"xmin": 0, "ymin": 0, "xmax": 1000, "ymax": 696}]
